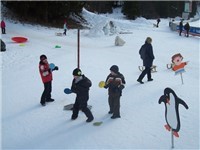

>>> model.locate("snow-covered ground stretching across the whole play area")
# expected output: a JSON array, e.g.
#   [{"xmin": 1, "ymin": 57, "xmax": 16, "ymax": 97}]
[{"xmin": 0, "ymin": 7, "xmax": 200, "ymax": 150}]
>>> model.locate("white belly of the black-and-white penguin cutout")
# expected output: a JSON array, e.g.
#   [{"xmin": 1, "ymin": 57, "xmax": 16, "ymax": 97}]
[{"xmin": 167, "ymin": 99, "xmax": 178, "ymax": 129}]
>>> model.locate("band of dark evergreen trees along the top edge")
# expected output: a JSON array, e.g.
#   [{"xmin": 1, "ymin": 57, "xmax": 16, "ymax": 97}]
[{"xmin": 1, "ymin": 1, "xmax": 197, "ymax": 26}]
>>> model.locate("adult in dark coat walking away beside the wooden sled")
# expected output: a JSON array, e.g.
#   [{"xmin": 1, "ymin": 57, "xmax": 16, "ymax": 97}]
[{"xmin": 137, "ymin": 37, "xmax": 155, "ymax": 84}]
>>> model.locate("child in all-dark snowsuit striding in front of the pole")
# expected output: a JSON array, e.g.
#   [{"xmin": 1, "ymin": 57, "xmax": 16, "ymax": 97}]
[{"xmin": 71, "ymin": 68, "xmax": 94, "ymax": 122}]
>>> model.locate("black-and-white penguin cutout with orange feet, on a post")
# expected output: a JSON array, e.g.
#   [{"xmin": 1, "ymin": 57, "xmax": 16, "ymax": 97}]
[{"xmin": 158, "ymin": 88, "xmax": 188, "ymax": 137}]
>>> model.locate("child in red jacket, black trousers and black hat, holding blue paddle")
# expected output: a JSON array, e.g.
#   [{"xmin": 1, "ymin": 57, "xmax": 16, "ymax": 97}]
[{"xmin": 39, "ymin": 55, "xmax": 58, "ymax": 106}]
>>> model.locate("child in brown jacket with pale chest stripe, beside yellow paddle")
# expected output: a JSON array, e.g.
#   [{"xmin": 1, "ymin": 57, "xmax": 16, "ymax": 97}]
[{"xmin": 104, "ymin": 65, "xmax": 126, "ymax": 119}]
